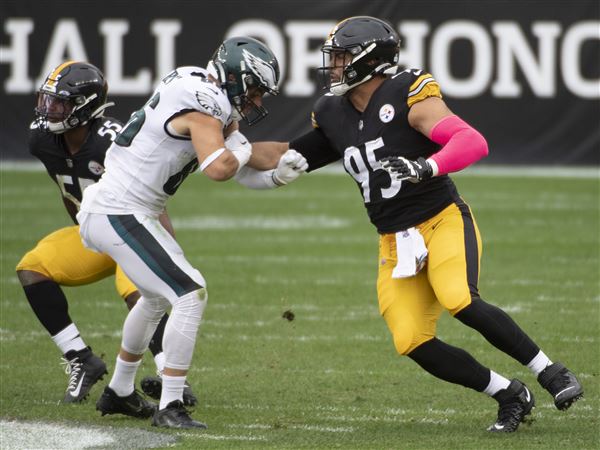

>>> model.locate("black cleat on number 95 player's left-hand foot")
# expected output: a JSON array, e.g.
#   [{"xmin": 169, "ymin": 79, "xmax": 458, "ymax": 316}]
[{"xmin": 488, "ymin": 380, "xmax": 535, "ymax": 433}]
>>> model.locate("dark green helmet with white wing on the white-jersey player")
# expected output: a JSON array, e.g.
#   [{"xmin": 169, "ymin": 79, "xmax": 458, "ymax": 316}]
[{"xmin": 208, "ymin": 37, "xmax": 279, "ymax": 125}]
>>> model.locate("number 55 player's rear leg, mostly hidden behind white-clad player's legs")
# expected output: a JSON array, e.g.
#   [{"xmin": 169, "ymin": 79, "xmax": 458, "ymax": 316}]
[{"xmin": 115, "ymin": 266, "xmax": 198, "ymax": 406}]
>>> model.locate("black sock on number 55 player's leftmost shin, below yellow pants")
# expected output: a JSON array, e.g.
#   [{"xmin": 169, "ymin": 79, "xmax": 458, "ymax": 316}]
[{"xmin": 23, "ymin": 280, "xmax": 73, "ymax": 336}]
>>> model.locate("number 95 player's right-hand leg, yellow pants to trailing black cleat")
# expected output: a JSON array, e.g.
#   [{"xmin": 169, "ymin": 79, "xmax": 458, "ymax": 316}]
[{"xmin": 428, "ymin": 202, "xmax": 583, "ymax": 409}]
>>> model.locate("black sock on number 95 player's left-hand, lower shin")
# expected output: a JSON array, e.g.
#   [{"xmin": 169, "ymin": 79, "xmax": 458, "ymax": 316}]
[{"xmin": 408, "ymin": 338, "xmax": 490, "ymax": 392}]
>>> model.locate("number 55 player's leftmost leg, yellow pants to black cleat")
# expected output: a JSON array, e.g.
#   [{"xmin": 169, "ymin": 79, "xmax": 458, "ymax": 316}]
[{"xmin": 17, "ymin": 226, "xmax": 114, "ymax": 403}]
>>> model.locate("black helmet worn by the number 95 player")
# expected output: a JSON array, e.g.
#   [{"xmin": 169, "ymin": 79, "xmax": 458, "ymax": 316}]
[{"xmin": 318, "ymin": 16, "xmax": 400, "ymax": 95}]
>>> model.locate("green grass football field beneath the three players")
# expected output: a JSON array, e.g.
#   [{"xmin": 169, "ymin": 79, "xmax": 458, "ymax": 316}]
[{"xmin": 0, "ymin": 167, "xmax": 600, "ymax": 449}]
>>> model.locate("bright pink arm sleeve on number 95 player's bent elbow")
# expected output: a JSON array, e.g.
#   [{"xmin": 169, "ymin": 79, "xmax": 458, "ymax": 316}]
[{"xmin": 429, "ymin": 116, "xmax": 488, "ymax": 175}]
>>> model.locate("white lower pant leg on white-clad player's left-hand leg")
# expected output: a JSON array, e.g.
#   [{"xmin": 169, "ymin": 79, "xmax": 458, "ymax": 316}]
[{"xmin": 121, "ymin": 297, "xmax": 171, "ymax": 355}]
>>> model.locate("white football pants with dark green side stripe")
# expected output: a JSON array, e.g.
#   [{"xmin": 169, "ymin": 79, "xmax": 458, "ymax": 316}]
[{"xmin": 77, "ymin": 212, "xmax": 208, "ymax": 370}]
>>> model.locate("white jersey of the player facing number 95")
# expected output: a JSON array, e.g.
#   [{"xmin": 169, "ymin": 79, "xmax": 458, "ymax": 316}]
[{"xmin": 81, "ymin": 66, "xmax": 232, "ymax": 215}]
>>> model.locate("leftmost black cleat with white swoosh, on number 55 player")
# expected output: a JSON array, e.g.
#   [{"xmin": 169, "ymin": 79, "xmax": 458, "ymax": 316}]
[{"xmin": 61, "ymin": 347, "xmax": 108, "ymax": 403}]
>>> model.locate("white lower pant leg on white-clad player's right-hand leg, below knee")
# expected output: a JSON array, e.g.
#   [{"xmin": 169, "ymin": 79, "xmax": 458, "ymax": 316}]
[{"xmin": 163, "ymin": 288, "xmax": 208, "ymax": 370}]
